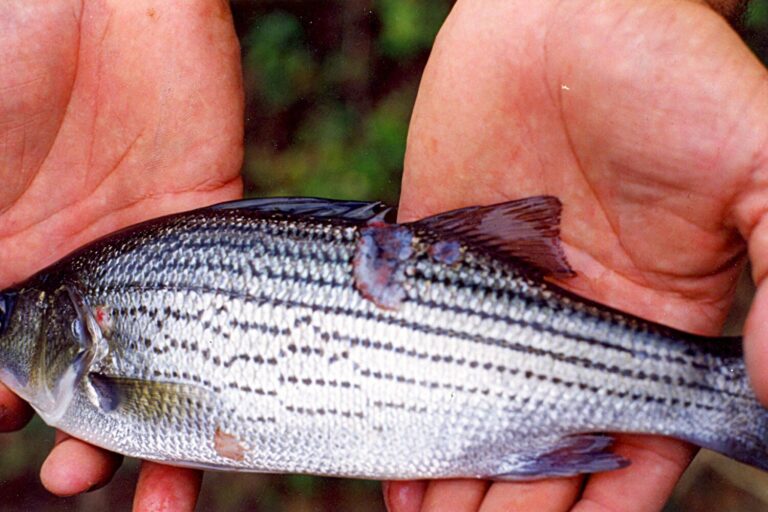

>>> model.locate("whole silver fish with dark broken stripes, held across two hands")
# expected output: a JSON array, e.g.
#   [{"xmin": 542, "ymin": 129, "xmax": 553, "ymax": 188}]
[{"xmin": 0, "ymin": 196, "xmax": 768, "ymax": 480}]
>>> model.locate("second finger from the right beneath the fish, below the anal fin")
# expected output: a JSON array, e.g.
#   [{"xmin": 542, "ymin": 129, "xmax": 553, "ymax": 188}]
[{"xmin": 479, "ymin": 477, "xmax": 582, "ymax": 512}]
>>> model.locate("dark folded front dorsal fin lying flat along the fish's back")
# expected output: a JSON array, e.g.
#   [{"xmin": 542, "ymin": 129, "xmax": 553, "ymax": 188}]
[{"xmin": 211, "ymin": 197, "xmax": 395, "ymax": 221}]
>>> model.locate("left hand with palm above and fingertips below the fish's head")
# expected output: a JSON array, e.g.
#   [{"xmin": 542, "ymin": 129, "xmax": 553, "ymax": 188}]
[{"xmin": 0, "ymin": 0, "xmax": 243, "ymax": 511}]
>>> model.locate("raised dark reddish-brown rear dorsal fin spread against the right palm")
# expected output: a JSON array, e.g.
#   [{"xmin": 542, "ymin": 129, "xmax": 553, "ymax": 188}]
[{"xmin": 412, "ymin": 196, "xmax": 575, "ymax": 277}]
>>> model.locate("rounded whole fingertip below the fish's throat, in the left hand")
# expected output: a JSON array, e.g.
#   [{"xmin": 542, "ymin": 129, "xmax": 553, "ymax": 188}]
[{"xmin": 40, "ymin": 432, "xmax": 123, "ymax": 496}]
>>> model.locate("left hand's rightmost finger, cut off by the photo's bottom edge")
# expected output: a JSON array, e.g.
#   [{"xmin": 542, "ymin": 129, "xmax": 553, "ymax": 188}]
[{"xmin": 133, "ymin": 461, "xmax": 203, "ymax": 512}]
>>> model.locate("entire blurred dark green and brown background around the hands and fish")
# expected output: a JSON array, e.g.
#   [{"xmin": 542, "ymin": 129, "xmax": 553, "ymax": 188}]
[{"xmin": 0, "ymin": 0, "xmax": 768, "ymax": 512}]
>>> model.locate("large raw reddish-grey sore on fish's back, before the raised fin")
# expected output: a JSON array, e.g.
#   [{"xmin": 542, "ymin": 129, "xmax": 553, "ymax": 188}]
[{"xmin": 353, "ymin": 221, "xmax": 413, "ymax": 309}]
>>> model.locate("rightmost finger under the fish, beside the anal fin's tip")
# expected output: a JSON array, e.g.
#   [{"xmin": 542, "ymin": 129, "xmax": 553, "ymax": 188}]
[{"xmin": 573, "ymin": 435, "xmax": 696, "ymax": 512}]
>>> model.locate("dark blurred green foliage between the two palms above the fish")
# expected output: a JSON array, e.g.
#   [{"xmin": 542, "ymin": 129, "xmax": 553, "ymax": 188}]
[{"xmin": 243, "ymin": 0, "xmax": 451, "ymax": 203}]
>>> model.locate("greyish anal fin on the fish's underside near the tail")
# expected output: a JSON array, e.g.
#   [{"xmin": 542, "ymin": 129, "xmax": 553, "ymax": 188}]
[{"xmin": 491, "ymin": 434, "xmax": 630, "ymax": 480}]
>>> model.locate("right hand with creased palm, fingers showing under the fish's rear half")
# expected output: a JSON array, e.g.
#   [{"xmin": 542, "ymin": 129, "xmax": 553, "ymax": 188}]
[{"xmin": 385, "ymin": 0, "xmax": 768, "ymax": 512}]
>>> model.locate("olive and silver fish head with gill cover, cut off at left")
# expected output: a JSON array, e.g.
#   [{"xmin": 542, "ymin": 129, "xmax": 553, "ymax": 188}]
[{"xmin": 0, "ymin": 285, "xmax": 95, "ymax": 423}]
